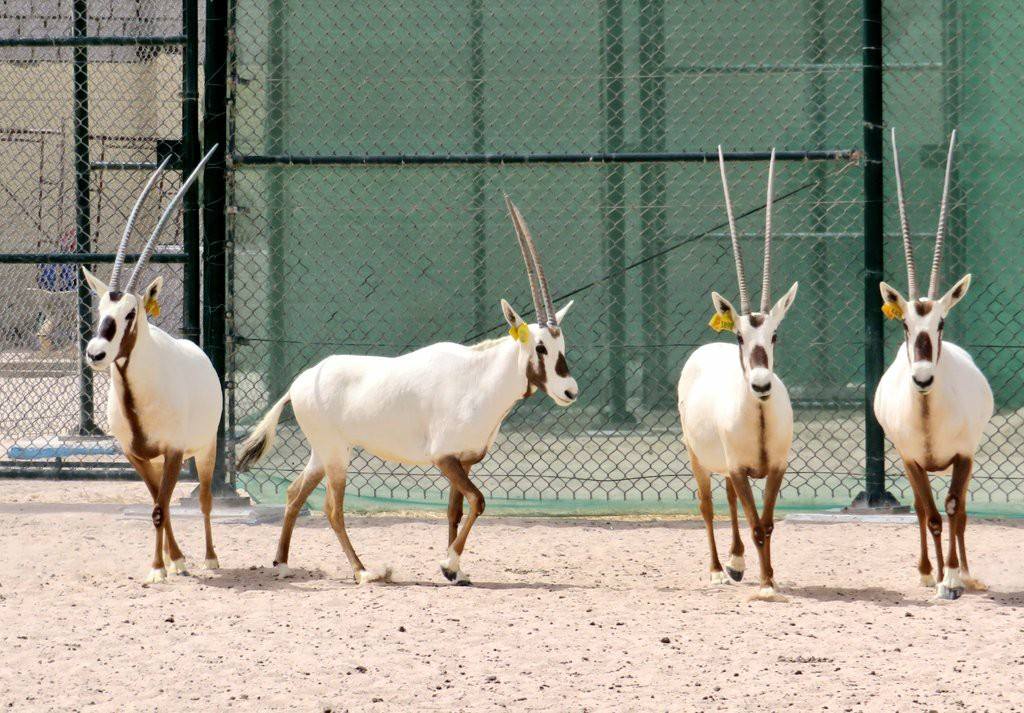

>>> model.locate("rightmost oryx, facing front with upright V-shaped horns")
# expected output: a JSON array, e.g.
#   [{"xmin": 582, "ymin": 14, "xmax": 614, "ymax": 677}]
[{"xmin": 874, "ymin": 130, "xmax": 992, "ymax": 599}]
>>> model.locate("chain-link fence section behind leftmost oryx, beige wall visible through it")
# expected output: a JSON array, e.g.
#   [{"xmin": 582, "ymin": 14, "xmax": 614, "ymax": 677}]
[{"xmin": 0, "ymin": 0, "xmax": 198, "ymax": 477}]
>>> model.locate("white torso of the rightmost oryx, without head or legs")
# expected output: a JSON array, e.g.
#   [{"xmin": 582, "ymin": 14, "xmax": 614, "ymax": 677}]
[{"xmin": 874, "ymin": 341, "xmax": 993, "ymax": 473}]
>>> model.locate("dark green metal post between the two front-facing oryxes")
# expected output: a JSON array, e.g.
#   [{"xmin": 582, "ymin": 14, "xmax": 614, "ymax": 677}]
[{"xmin": 853, "ymin": 0, "xmax": 897, "ymax": 507}]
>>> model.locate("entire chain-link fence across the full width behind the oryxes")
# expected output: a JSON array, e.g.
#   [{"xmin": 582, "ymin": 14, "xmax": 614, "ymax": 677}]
[{"xmin": 0, "ymin": 0, "xmax": 1024, "ymax": 511}]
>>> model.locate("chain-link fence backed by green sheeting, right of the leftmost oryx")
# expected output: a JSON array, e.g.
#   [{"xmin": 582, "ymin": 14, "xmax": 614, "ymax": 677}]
[{"xmin": 229, "ymin": 0, "xmax": 1024, "ymax": 509}]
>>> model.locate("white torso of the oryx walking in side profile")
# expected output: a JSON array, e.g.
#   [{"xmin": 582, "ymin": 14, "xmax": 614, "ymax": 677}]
[{"xmin": 288, "ymin": 338, "xmax": 548, "ymax": 465}]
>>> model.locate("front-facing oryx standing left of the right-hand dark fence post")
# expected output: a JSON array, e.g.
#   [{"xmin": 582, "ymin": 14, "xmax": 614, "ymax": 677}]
[{"xmin": 679, "ymin": 146, "xmax": 798, "ymax": 599}]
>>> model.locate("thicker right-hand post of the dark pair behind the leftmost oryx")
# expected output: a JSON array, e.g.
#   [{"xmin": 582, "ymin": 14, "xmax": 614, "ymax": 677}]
[{"xmin": 197, "ymin": 0, "xmax": 234, "ymax": 495}]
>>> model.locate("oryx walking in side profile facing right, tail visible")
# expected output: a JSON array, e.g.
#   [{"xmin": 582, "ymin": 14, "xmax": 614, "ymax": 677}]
[{"xmin": 238, "ymin": 197, "xmax": 579, "ymax": 584}]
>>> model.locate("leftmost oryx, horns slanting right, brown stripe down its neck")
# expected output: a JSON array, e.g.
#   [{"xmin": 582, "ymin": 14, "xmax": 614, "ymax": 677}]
[{"xmin": 82, "ymin": 146, "xmax": 221, "ymax": 583}]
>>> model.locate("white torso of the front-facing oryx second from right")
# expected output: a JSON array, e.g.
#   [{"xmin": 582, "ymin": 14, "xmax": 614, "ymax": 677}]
[{"xmin": 679, "ymin": 342, "xmax": 793, "ymax": 475}]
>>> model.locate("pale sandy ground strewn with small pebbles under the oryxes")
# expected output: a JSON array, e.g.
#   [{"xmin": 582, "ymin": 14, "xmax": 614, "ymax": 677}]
[{"xmin": 0, "ymin": 480, "xmax": 1024, "ymax": 711}]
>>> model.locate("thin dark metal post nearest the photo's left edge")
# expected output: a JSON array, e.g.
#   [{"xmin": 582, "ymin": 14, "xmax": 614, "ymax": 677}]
[{"xmin": 72, "ymin": 0, "xmax": 101, "ymax": 435}]
